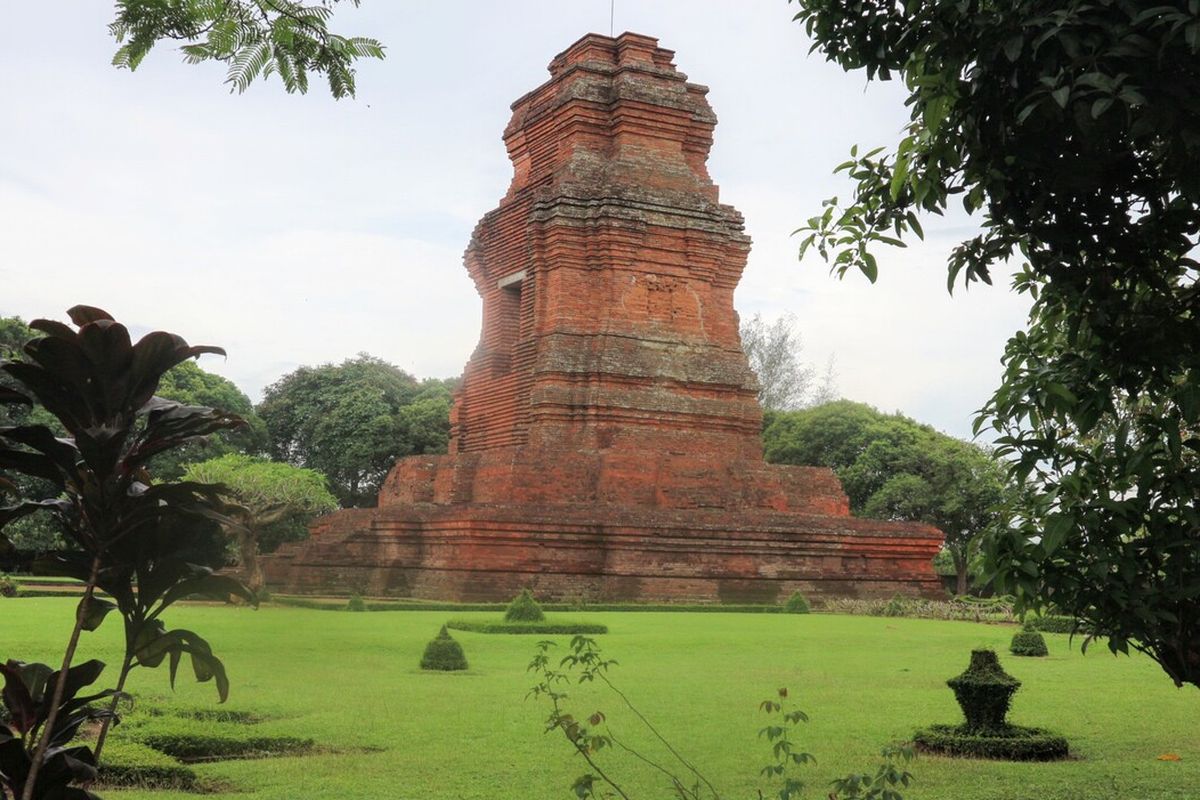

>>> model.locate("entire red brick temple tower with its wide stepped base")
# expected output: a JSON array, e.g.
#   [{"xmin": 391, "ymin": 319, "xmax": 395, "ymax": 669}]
[{"xmin": 265, "ymin": 34, "xmax": 942, "ymax": 602}]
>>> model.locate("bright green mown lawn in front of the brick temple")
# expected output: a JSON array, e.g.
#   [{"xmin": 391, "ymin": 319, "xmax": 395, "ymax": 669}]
[{"xmin": 0, "ymin": 599, "xmax": 1200, "ymax": 800}]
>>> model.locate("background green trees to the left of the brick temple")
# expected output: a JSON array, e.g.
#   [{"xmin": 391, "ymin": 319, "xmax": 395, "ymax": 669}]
[{"xmin": 0, "ymin": 317, "xmax": 456, "ymax": 575}]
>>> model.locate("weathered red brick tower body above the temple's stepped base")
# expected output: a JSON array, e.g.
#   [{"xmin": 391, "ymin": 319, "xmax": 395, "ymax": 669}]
[{"xmin": 452, "ymin": 36, "xmax": 761, "ymax": 462}]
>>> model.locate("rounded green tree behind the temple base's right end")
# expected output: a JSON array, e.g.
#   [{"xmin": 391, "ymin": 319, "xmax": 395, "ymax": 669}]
[{"xmin": 763, "ymin": 401, "xmax": 1009, "ymax": 594}]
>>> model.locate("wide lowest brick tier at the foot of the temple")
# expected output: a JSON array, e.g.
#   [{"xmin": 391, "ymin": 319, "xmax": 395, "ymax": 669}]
[{"xmin": 265, "ymin": 505, "xmax": 943, "ymax": 603}]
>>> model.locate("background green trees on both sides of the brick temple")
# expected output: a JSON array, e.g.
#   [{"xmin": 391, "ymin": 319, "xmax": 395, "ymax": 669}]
[{"xmin": 0, "ymin": 314, "xmax": 1007, "ymax": 594}]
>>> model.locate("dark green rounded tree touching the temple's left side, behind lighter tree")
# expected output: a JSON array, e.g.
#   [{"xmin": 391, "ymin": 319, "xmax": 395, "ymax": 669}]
[{"xmin": 258, "ymin": 354, "xmax": 452, "ymax": 506}]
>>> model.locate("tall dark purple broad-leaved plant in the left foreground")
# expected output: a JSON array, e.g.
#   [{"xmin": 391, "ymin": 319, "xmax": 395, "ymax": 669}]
[{"xmin": 0, "ymin": 306, "xmax": 253, "ymax": 800}]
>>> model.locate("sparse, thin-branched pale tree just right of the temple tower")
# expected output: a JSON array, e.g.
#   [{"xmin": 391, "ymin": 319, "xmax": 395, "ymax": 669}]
[{"xmin": 738, "ymin": 314, "xmax": 838, "ymax": 411}]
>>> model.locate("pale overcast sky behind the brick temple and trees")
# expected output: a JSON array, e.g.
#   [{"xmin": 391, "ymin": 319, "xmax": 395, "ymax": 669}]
[{"xmin": 0, "ymin": 0, "xmax": 1027, "ymax": 437}]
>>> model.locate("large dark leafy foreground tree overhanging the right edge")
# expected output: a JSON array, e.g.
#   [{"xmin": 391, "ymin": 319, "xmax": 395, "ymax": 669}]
[{"xmin": 797, "ymin": 0, "xmax": 1200, "ymax": 686}]
